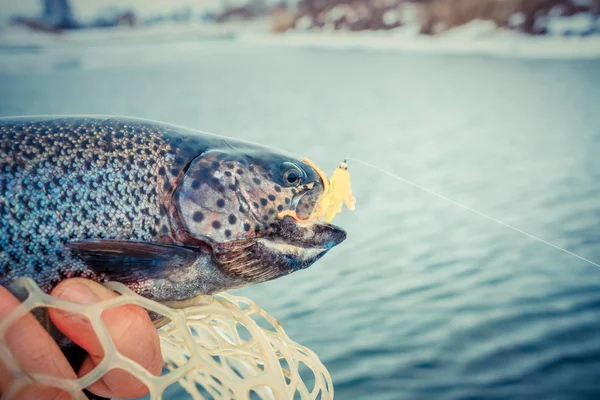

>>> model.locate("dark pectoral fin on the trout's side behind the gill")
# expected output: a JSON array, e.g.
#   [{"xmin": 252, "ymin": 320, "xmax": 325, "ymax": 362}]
[{"xmin": 67, "ymin": 240, "xmax": 200, "ymax": 283}]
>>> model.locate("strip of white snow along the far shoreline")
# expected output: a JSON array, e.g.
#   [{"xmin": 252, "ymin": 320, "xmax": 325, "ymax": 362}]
[{"xmin": 0, "ymin": 21, "xmax": 600, "ymax": 59}]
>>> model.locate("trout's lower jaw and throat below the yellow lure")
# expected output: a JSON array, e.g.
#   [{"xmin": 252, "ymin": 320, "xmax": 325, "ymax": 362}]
[{"xmin": 214, "ymin": 217, "xmax": 346, "ymax": 283}]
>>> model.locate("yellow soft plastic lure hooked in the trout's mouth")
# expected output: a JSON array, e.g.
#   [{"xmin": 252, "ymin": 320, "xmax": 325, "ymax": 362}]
[{"xmin": 278, "ymin": 158, "xmax": 356, "ymax": 222}]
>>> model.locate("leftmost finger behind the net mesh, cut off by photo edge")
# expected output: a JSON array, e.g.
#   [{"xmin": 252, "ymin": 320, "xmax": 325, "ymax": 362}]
[{"xmin": 0, "ymin": 286, "xmax": 77, "ymax": 399}]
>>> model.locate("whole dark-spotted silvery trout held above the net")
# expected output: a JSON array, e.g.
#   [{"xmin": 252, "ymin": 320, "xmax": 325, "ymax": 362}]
[{"xmin": 0, "ymin": 116, "xmax": 346, "ymax": 302}]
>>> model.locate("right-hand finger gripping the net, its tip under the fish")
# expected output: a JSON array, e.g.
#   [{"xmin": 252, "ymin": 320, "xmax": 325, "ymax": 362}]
[{"xmin": 50, "ymin": 278, "xmax": 162, "ymax": 398}]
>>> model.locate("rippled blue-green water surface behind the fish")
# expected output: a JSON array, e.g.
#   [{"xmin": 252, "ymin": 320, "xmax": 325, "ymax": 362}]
[{"xmin": 0, "ymin": 42, "xmax": 600, "ymax": 400}]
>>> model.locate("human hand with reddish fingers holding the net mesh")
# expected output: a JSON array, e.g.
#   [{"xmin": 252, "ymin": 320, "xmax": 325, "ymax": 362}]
[{"xmin": 0, "ymin": 278, "xmax": 162, "ymax": 400}]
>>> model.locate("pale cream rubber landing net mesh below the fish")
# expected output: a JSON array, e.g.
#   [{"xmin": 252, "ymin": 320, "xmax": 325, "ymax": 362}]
[{"xmin": 0, "ymin": 278, "xmax": 333, "ymax": 400}]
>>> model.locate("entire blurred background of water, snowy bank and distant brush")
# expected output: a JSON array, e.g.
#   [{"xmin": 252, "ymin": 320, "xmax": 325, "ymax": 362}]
[{"xmin": 0, "ymin": 0, "xmax": 600, "ymax": 400}]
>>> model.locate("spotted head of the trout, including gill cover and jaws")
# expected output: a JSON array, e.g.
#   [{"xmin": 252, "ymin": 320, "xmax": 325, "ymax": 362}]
[{"xmin": 173, "ymin": 147, "xmax": 346, "ymax": 283}]
